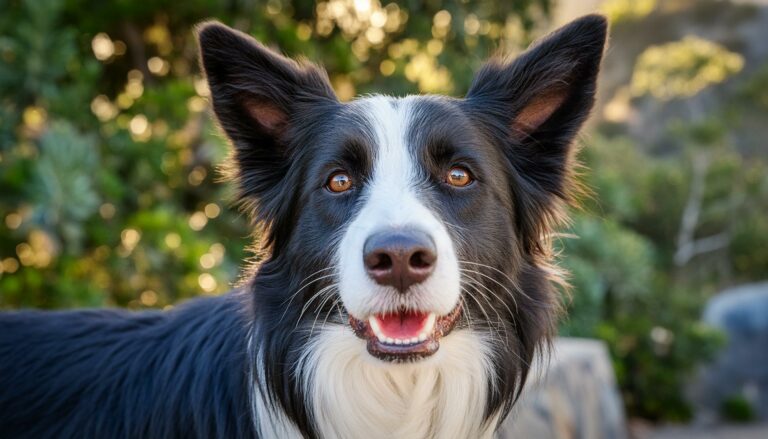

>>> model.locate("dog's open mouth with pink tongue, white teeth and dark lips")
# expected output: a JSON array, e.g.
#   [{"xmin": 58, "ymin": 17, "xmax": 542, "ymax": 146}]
[{"xmin": 349, "ymin": 305, "xmax": 461, "ymax": 362}]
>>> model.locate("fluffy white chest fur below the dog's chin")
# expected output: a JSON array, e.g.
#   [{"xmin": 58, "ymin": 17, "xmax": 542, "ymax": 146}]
[{"xmin": 299, "ymin": 328, "xmax": 493, "ymax": 438}]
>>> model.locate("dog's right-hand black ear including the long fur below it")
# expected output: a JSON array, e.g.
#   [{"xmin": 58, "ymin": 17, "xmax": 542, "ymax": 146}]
[{"xmin": 465, "ymin": 15, "xmax": 607, "ymax": 254}]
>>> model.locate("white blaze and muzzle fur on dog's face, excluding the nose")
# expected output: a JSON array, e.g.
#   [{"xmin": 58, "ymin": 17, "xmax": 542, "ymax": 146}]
[{"xmin": 337, "ymin": 96, "xmax": 460, "ymax": 318}]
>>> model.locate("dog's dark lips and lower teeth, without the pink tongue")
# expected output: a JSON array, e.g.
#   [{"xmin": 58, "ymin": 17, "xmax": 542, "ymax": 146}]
[{"xmin": 349, "ymin": 304, "xmax": 461, "ymax": 362}]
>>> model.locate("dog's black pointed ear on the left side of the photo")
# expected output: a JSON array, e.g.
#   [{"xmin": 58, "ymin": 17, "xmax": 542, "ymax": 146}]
[{"xmin": 197, "ymin": 22, "xmax": 338, "ymax": 234}]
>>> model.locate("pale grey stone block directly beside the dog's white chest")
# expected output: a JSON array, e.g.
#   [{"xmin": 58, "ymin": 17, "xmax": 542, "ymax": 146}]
[{"xmin": 497, "ymin": 338, "xmax": 627, "ymax": 439}]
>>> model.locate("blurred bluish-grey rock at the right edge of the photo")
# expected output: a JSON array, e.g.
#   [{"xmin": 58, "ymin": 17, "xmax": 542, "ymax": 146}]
[{"xmin": 689, "ymin": 282, "xmax": 768, "ymax": 422}]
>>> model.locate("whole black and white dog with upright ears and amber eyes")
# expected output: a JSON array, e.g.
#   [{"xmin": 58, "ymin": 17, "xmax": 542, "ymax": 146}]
[{"xmin": 0, "ymin": 16, "xmax": 606, "ymax": 438}]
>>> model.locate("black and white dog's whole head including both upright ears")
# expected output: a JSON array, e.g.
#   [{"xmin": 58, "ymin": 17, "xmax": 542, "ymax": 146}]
[{"xmin": 199, "ymin": 11, "xmax": 606, "ymax": 430}]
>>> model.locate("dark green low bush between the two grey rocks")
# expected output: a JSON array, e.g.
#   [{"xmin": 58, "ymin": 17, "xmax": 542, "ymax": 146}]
[{"xmin": 596, "ymin": 302, "xmax": 723, "ymax": 422}]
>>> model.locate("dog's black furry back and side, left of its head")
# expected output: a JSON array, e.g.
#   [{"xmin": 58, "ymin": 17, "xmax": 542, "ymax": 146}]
[{"xmin": 0, "ymin": 294, "xmax": 254, "ymax": 438}]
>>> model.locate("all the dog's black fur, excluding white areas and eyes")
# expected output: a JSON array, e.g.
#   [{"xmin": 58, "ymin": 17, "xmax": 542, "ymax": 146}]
[{"xmin": 0, "ymin": 16, "xmax": 606, "ymax": 438}]
